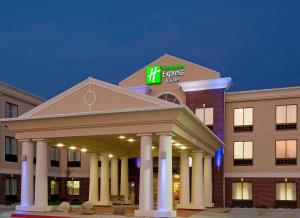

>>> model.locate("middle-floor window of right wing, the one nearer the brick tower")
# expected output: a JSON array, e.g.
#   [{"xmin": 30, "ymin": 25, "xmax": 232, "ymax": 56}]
[{"xmin": 233, "ymin": 141, "xmax": 253, "ymax": 166}]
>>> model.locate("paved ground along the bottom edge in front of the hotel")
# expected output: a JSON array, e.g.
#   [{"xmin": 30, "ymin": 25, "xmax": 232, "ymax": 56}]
[{"xmin": 0, "ymin": 205, "xmax": 300, "ymax": 218}]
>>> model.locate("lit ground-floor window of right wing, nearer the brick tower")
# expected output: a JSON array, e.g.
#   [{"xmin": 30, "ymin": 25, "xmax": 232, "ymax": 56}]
[{"xmin": 232, "ymin": 182, "xmax": 252, "ymax": 200}]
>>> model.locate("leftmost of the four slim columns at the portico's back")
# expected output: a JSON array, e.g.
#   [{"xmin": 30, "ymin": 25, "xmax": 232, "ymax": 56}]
[{"xmin": 89, "ymin": 153, "xmax": 99, "ymax": 205}]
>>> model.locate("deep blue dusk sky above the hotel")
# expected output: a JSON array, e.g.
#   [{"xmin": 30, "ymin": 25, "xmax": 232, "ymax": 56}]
[{"xmin": 0, "ymin": 0, "xmax": 300, "ymax": 98}]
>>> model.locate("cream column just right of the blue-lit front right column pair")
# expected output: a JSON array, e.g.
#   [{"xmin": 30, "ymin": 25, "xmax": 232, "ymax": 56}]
[{"xmin": 177, "ymin": 150, "xmax": 190, "ymax": 209}]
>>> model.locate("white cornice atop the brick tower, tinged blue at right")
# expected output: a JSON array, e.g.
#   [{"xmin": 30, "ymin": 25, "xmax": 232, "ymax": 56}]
[{"xmin": 178, "ymin": 77, "xmax": 231, "ymax": 92}]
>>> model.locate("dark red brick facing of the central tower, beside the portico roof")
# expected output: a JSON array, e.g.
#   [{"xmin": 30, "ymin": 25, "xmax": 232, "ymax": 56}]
[{"xmin": 186, "ymin": 89, "xmax": 225, "ymax": 207}]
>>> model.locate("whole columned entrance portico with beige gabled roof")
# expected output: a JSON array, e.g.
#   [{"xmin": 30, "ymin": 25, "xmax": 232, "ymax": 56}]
[{"xmin": 4, "ymin": 78, "xmax": 222, "ymax": 217}]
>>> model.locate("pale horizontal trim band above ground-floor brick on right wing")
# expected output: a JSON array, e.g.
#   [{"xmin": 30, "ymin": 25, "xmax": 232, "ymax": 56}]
[{"xmin": 224, "ymin": 172, "xmax": 300, "ymax": 178}]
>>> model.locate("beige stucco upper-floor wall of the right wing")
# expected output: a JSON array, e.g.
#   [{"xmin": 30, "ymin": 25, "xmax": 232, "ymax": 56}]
[{"xmin": 224, "ymin": 93, "xmax": 300, "ymax": 177}]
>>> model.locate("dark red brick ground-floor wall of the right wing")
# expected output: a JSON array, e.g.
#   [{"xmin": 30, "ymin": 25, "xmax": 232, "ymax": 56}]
[{"xmin": 225, "ymin": 178, "xmax": 300, "ymax": 208}]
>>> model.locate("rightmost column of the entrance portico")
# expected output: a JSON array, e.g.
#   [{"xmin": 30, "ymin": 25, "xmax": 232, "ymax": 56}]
[{"xmin": 203, "ymin": 155, "xmax": 214, "ymax": 207}]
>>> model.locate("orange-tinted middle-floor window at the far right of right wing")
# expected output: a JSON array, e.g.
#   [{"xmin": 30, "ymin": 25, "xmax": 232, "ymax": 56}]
[{"xmin": 276, "ymin": 140, "xmax": 297, "ymax": 165}]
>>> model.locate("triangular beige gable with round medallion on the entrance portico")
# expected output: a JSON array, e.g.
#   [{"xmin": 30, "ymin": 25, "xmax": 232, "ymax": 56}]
[{"xmin": 19, "ymin": 77, "xmax": 175, "ymax": 119}]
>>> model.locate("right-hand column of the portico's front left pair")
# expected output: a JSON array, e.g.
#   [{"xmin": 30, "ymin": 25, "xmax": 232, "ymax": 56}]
[{"xmin": 33, "ymin": 139, "xmax": 51, "ymax": 211}]
